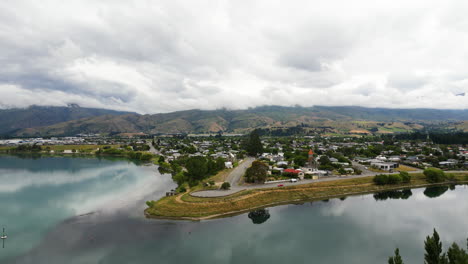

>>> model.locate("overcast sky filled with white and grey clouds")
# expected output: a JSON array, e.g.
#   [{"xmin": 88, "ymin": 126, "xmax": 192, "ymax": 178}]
[{"xmin": 0, "ymin": 0, "xmax": 468, "ymax": 113}]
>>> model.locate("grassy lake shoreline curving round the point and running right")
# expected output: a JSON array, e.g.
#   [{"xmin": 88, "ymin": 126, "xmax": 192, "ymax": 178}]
[{"xmin": 144, "ymin": 173, "xmax": 468, "ymax": 221}]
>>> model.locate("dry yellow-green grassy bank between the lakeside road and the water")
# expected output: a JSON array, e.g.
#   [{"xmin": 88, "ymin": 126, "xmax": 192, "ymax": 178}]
[{"xmin": 145, "ymin": 172, "xmax": 468, "ymax": 220}]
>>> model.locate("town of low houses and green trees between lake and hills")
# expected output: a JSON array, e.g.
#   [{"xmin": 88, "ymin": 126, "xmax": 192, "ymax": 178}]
[{"xmin": 0, "ymin": 131, "xmax": 468, "ymax": 190}]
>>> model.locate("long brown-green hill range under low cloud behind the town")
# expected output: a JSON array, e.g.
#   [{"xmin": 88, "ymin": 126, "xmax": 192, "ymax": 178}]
[{"xmin": 11, "ymin": 106, "xmax": 468, "ymax": 136}]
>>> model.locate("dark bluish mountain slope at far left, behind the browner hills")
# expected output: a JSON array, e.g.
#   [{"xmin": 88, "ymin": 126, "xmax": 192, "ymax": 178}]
[{"xmin": 0, "ymin": 104, "xmax": 133, "ymax": 135}]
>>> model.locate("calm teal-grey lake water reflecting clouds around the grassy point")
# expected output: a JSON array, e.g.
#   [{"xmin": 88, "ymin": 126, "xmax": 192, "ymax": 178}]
[{"xmin": 0, "ymin": 156, "xmax": 468, "ymax": 264}]
